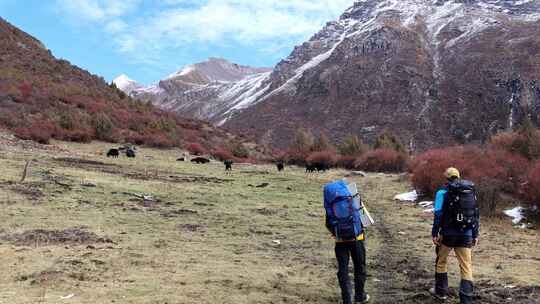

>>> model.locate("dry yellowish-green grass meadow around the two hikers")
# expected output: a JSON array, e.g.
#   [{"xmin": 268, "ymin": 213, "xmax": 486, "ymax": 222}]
[{"xmin": 0, "ymin": 134, "xmax": 540, "ymax": 304}]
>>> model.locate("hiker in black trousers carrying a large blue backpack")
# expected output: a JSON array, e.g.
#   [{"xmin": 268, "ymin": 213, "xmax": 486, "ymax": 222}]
[{"xmin": 324, "ymin": 180, "xmax": 372, "ymax": 304}]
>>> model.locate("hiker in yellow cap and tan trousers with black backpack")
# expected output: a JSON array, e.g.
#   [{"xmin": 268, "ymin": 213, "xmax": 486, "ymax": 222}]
[{"xmin": 429, "ymin": 168, "xmax": 480, "ymax": 304}]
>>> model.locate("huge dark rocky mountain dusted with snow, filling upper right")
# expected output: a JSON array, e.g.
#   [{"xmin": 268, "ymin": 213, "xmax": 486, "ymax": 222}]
[{"xmin": 124, "ymin": 0, "xmax": 540, "ymax": 149}]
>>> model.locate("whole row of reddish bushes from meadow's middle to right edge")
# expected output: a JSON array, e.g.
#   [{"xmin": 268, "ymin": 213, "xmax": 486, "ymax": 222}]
[{"xmin": 284, "ymin": 123, "xmax": 540, "ymax": 216}]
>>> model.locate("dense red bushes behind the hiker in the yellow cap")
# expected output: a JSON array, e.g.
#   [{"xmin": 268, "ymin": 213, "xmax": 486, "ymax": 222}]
[{"xmin": 408, "ymin": 119, "xmax": 540, "ymax": 215}]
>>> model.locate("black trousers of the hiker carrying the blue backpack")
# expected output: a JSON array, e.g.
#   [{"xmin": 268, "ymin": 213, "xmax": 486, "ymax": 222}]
[{"xmin": 336, "ymin": 241, "xmax": 366, "ymax": 304}]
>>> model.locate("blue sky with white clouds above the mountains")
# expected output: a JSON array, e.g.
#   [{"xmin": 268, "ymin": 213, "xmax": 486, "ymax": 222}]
[{"xmin": 0, "ymin": 0, "xmax": 354, "ymax": 84}]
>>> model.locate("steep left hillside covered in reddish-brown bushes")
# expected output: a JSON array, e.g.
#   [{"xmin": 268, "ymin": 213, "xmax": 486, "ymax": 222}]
[{"xmin": 0, "ymin": 18, "xmax": 262, "ymax": 157}]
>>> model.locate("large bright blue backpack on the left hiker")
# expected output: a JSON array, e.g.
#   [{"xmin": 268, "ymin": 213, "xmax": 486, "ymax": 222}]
[{"xmin": 324, "ymin": 180, "xmax": 362, "ymax": 241}]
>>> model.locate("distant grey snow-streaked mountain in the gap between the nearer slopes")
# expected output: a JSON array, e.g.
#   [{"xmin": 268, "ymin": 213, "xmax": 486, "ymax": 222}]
[{"xmin": 125, "ymin": 58, "xmax": 271, "ymax": 123}]
